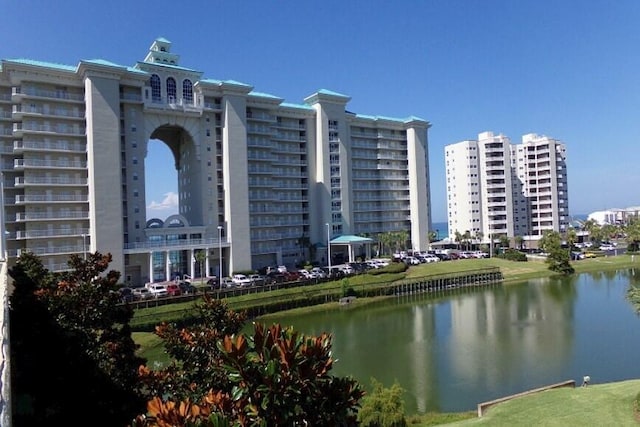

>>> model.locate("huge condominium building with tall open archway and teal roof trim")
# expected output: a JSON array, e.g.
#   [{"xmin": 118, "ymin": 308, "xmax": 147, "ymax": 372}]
[{"xmin": 0, "ymin": 38, "xmax": 431, "ymax": 283}]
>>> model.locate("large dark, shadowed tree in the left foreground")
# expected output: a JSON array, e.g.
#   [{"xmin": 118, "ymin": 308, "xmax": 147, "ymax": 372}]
[{"xmin": 9, "ymin": 252, "xmax": 144, "ymax": 427}]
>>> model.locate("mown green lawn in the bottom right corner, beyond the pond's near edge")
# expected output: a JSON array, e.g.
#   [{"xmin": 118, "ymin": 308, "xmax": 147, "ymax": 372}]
[{"xmin": 442, "ymin": 380, "xmax": 640, "ymax": 427}]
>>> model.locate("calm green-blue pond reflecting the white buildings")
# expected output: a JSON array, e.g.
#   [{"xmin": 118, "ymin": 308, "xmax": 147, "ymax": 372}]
[{"xmin": 258, "ymin": 270, "xmax": 640, "ymax": 413}]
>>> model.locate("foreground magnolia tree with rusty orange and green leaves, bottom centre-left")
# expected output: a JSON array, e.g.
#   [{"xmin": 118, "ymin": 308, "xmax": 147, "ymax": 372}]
[{"xmin": 134, "ymin": 323, "xmax": 364, "ymax": 427}]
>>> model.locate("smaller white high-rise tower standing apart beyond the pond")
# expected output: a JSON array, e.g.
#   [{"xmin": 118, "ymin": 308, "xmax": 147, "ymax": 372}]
[{"xmin": 445, "ymin": 132, "xmax": 569, "ymax": 242}]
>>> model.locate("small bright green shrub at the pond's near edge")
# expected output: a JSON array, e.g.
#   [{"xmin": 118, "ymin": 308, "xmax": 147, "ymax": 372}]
[{"xmin": 358, "ymin": 378, "xmax": 407, "ymax": 427}]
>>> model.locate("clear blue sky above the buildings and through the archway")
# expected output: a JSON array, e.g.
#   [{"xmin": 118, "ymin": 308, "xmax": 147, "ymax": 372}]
[{"xmin": 0, "ymin": 0, "xmax": 640, "ymax": 221}]
